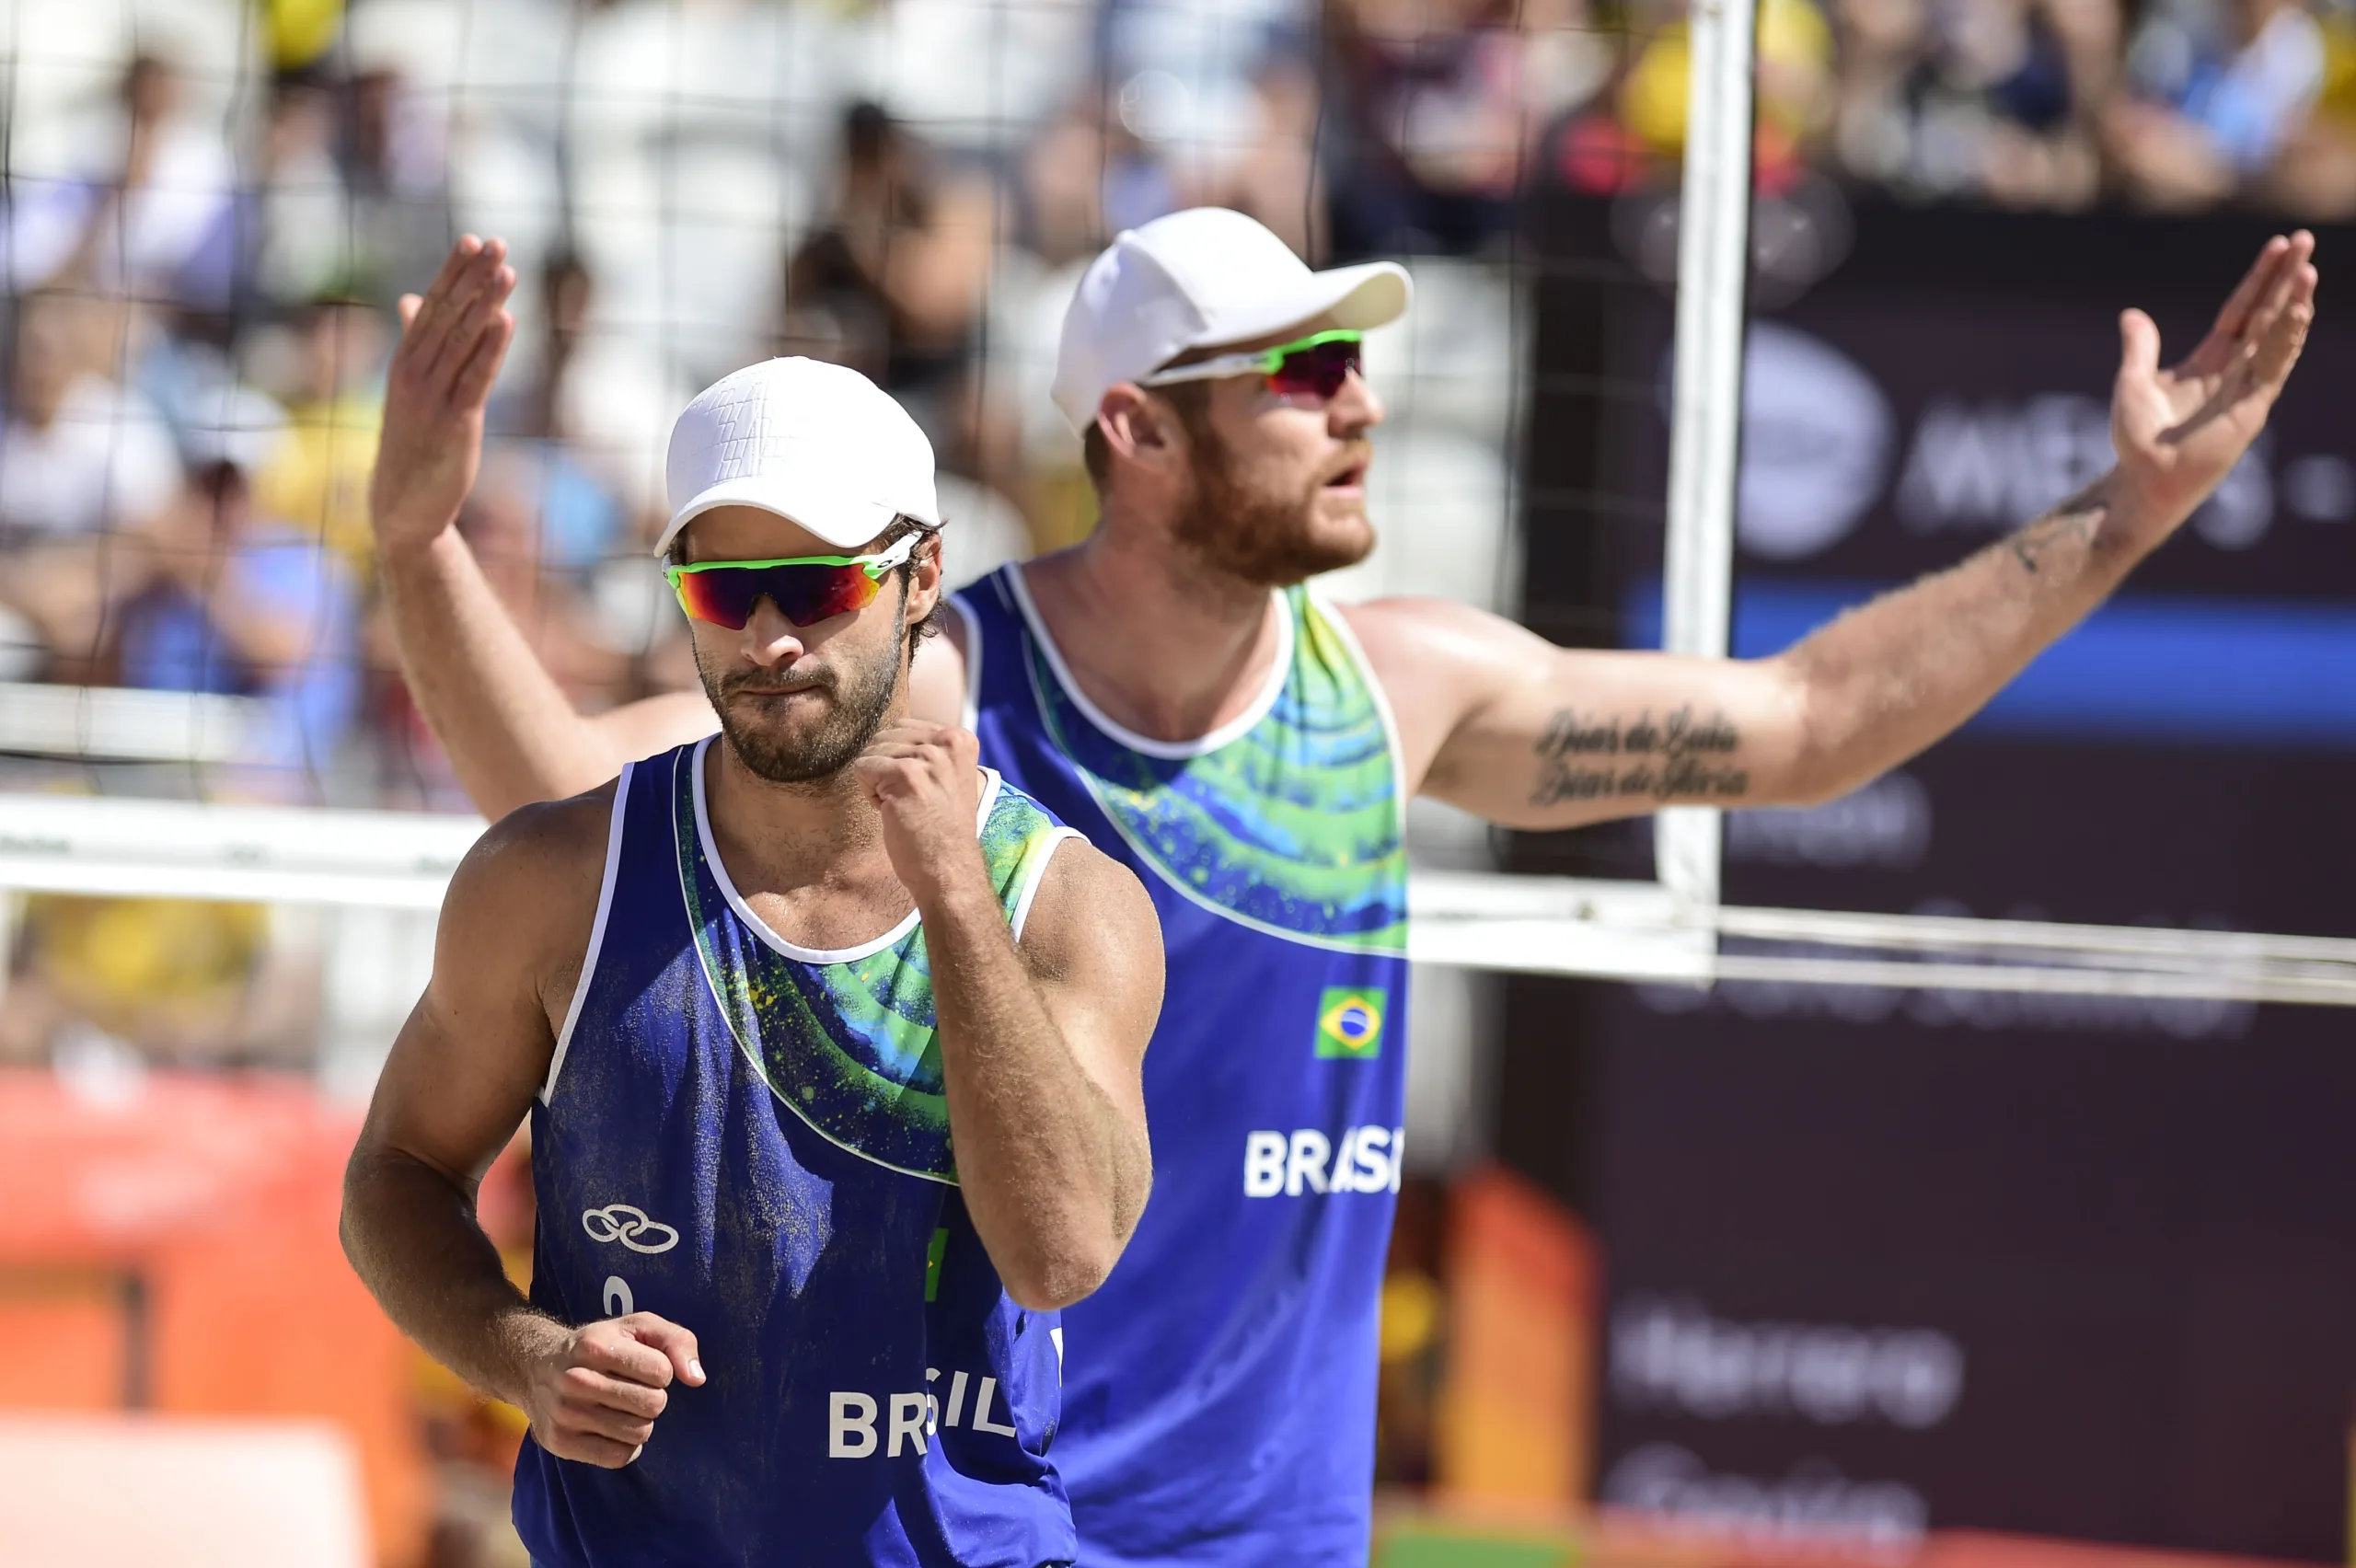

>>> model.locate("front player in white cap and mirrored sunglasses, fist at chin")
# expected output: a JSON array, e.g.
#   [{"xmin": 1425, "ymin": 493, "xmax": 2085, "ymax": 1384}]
[{"xmin": 344, "ymin": 294, "xmax": 1161, "ymax": 1568}]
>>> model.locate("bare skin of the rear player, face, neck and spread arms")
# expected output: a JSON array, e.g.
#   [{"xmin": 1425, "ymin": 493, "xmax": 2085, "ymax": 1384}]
[{"xmin": 379, "ymin": 231, "xmax": 2316, "ymax": 829}]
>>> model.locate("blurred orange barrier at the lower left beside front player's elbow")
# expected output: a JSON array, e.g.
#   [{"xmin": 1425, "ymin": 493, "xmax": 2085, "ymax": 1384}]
[{"xmin": 0, "ymin": 1071, "xmax": 429, "ymax": 1568}]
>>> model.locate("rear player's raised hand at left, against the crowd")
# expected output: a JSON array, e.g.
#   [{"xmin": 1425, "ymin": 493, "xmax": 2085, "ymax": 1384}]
[{"xmin": 367, "ymin": 233, "xmax": 516, "ymax": 556}]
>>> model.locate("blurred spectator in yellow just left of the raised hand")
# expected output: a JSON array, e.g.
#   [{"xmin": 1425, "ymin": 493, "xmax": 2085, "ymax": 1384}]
[{"xmin": 254, "ymin": 294, "xmax": 391, "ymax": 582}]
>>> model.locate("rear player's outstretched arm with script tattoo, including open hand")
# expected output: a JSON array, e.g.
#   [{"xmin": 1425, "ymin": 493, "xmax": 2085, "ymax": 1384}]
[{"xmin": 1350, "ymin": 233, "xmax": 2316, "ymax": 829}]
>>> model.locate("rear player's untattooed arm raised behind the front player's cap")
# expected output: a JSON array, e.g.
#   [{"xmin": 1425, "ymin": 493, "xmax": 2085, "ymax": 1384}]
[{"xmin": 367, "ymin": 236, "xmax": 716, "ymax": 819}]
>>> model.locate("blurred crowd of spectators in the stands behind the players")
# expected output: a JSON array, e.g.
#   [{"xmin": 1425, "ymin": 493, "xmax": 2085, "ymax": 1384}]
[{"xmin": 0, "ymin": 0, "xmax": 2356, "ymax": 805}]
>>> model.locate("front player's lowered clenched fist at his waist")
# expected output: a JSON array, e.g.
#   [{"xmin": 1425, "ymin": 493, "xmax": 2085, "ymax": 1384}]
[{"xmin": 523, "ymin": 1311, "xmax": 704, "ymax": 1470}]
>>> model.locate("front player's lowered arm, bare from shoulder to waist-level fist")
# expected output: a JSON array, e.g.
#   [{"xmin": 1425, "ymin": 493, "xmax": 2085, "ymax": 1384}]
[{"xmin": 344, "ymin": 793, "xmax": 704, "ymax": 1470}]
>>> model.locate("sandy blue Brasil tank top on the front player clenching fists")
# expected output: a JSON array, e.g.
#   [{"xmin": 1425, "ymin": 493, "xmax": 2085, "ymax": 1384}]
[{"xmin": 516, "ymin": 742, "xmax": 1074, "ymax": 1568}]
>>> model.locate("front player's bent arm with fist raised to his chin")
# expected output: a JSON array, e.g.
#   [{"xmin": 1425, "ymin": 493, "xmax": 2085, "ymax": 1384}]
[{"xmin": 855, "ymin": 721, "xmax": 1161, "ymax": 1311}]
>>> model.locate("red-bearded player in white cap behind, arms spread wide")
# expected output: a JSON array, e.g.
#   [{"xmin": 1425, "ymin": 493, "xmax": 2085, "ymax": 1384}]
[{"xmin": 367, "ymin": 210, "xmax": 2316, "ymax": 1568}]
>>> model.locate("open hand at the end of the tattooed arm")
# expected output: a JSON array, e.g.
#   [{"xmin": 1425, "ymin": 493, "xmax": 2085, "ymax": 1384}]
[{"xmin": 2111, "ymin": 228, "xmax": 2316, "ymax": 541}]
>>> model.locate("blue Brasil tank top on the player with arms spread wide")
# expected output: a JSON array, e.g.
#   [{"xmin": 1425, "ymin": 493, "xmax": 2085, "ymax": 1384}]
[{"xmin": 959, "ymin": 568, "xmax": 1406, "ymax": 1568}]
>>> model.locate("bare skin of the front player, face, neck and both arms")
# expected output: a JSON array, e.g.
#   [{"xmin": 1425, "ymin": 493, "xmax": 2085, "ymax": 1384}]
[{"xmin": 344, "ymin": 485, "xmax": 1161, "ymax": 1467}]
